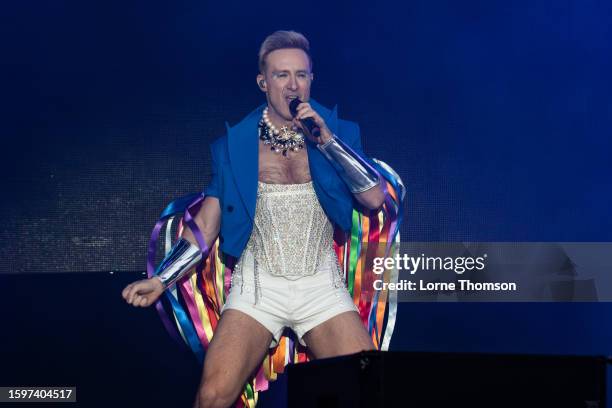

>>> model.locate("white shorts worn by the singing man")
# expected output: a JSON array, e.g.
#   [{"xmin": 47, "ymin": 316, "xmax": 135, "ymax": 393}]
[{"xmin": 221, "ymin": 255, "xmax": 357, "ymax": 348}]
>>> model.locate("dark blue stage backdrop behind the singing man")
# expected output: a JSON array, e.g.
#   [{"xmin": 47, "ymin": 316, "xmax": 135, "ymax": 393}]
[{"xmin": 0, "ymin": 0, "xmax": 612, "ymax": 404}]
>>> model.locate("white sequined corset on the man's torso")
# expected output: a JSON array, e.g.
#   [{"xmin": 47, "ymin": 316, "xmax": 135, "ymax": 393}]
[{"xmin": 246, "ymin": 181, "xmax": 334, "ymax": 279}]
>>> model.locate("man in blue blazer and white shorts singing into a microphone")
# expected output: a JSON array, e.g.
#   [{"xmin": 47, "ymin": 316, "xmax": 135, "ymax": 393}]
[{"xmin": 122, "ymin": 31, "xmax": 404, "ymax": 408}]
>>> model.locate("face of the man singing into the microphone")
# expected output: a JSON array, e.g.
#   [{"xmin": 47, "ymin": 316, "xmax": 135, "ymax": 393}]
[{"xmin": 258, "ymin": 48, "xmax": 312, "ymax": 121}]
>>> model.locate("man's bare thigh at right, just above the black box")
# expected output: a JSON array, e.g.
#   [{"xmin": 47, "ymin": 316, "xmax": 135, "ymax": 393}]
[{"xmin": 304, "ymin": 312, "xmax": 375, "ymax": 358}]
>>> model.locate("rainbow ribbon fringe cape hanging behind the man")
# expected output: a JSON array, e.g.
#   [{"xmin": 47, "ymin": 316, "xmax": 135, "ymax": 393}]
[{"xmin": 147, "ymin": 160, "xmax": 405, "ymax": 407}]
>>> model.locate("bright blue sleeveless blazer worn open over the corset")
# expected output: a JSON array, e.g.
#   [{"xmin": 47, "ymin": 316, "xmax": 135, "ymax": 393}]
[{"xmin": 204, "ymin": 99, "xmax": 364, "ymax": 258}]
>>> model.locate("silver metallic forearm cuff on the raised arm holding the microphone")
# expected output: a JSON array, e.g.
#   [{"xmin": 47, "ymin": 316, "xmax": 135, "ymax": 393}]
[{"xmin": 317, "ymin": 135, "xmax": 379, "ymax": 194}]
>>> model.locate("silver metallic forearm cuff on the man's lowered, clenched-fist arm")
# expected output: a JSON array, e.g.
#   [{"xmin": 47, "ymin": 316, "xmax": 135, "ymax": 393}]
[{"xmin": 155, "ymin": 238, "xmax": 202, "ymax": 289}]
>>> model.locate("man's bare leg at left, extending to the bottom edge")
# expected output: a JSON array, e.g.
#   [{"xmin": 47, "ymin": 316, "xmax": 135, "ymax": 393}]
[{"xmin": 194, "ymin": 309, "xmax": 272, "ymax": 408}]
